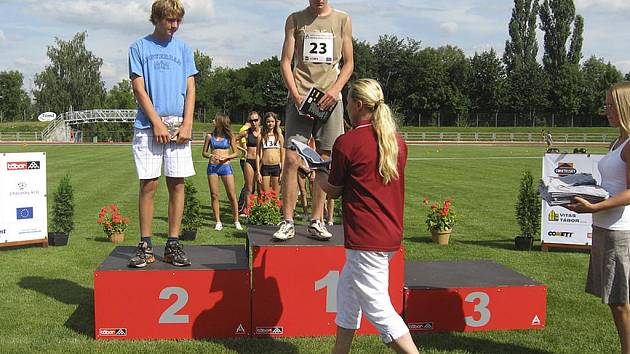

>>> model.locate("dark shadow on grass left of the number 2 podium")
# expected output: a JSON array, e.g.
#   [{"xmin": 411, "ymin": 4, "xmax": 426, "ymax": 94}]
[{"xmin": 18, "ymin": 277, "xmax": 94, "ymax": 338}]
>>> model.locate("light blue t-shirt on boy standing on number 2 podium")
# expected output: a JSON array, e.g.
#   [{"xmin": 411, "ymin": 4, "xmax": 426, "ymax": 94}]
[{"xmin": 129, "ymin": 35, "xmax": 198, "ymax": 129}]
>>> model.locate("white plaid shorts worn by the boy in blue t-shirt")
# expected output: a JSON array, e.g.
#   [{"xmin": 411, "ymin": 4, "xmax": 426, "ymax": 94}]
[{"xmin": 132, "ymin": 128, "xmax": 195, "ymax": 179}]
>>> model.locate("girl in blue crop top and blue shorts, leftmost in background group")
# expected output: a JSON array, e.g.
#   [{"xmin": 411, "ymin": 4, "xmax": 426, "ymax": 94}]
[{"xmin": 202, "ymin": 113, "xmax": 243, "ymax": 231}]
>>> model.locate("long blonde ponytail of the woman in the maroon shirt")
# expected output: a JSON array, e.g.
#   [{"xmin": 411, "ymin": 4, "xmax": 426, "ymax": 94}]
[{"xmin": 350, "ymin": 79, "xmax": 399, "ymax": 184}]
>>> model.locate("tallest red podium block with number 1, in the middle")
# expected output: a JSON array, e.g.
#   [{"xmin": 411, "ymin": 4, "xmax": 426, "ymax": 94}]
[{"xmin": 247, "ymin": 225, "xmax": 404, "ymax": 337}]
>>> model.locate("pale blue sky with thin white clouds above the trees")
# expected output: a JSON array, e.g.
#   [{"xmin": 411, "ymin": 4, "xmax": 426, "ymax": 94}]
[{"xmin": 0, "ymin": 0, "xmax": 630, "ymax": 91}]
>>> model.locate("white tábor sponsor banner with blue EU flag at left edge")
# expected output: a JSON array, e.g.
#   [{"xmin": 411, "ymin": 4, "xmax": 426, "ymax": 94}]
[{"xmin": 0, "ymin": 152, "xmax": 48, "ymax": 246}]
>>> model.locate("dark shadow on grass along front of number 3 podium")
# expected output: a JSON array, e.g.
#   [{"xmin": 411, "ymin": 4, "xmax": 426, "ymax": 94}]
[{"xmin": 412, "ymin": 333, "xmax": 551, "ymax": 354}]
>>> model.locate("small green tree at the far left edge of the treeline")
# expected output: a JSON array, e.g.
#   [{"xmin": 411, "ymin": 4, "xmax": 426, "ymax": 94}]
[{"xmin": 0, "ymin": 70, "xmax": 30, "ymax": 122}]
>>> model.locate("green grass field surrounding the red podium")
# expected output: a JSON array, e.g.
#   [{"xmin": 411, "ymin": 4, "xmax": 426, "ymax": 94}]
[{"xmin": 0, "ymin": 145, "xmax": 619, "ymax": 353}]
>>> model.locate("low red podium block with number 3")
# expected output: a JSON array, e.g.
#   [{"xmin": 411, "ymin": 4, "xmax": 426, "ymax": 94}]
[{"xmin": 404, "ymin": 261, "xmax": 547, "ymax": 332}]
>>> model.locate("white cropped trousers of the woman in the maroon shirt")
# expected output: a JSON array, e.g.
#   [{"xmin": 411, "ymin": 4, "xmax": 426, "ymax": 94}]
[{"xmin": 335, "ymin": 249, "xmax": 409, "ymax": 343}]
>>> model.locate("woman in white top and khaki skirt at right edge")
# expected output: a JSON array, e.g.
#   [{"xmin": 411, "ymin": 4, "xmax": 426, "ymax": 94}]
[{"xmin": 566, "ymin": 82, "xmax": 630, "ymax": 354}]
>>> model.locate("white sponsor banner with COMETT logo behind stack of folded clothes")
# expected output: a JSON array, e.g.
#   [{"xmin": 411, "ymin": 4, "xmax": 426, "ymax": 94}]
[{"xmin": 540, "ymin": 154, "xmax": 604, "ymax": 245}]
